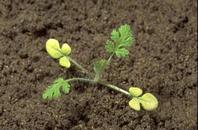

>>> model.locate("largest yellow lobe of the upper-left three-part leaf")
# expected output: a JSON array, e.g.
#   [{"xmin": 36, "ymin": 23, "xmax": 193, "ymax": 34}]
[{"xmin": 46, "ymin": 39, "xmax": 63, "ymax": 59}]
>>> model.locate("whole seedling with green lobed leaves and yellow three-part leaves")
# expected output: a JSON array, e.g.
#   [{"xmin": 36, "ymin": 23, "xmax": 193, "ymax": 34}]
[{"xmin": 42, "ymin": 24, "xmax": 158, "ymax": 111}]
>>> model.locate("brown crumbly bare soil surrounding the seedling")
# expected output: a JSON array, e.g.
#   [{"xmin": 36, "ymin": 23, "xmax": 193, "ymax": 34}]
[{"xmin": 0, "ymin": 0, "xmax": 197, "ymax": 130}]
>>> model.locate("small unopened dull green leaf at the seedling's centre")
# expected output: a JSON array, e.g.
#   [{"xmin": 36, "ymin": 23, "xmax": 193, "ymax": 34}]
[{"xmin": 94, "ymin": 59, "xmax": 107, "ymax": 80}]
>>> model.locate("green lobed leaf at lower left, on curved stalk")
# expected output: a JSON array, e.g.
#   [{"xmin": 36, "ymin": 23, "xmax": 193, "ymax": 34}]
[{"xmin": 42, "ymin": 78, "xmax": 70, "ymax": 100}]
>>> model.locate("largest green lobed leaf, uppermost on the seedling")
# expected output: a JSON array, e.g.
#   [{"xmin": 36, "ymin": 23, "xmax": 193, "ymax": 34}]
[{"xmin": 105, "ymin": 24, "xmax": 134, "ymax": 57}]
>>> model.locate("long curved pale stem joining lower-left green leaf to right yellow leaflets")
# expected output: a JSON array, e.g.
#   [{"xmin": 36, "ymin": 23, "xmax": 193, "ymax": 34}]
[{"xmin": 66, "ymin": 78, "xmax": 131, "ymax": 97}]
